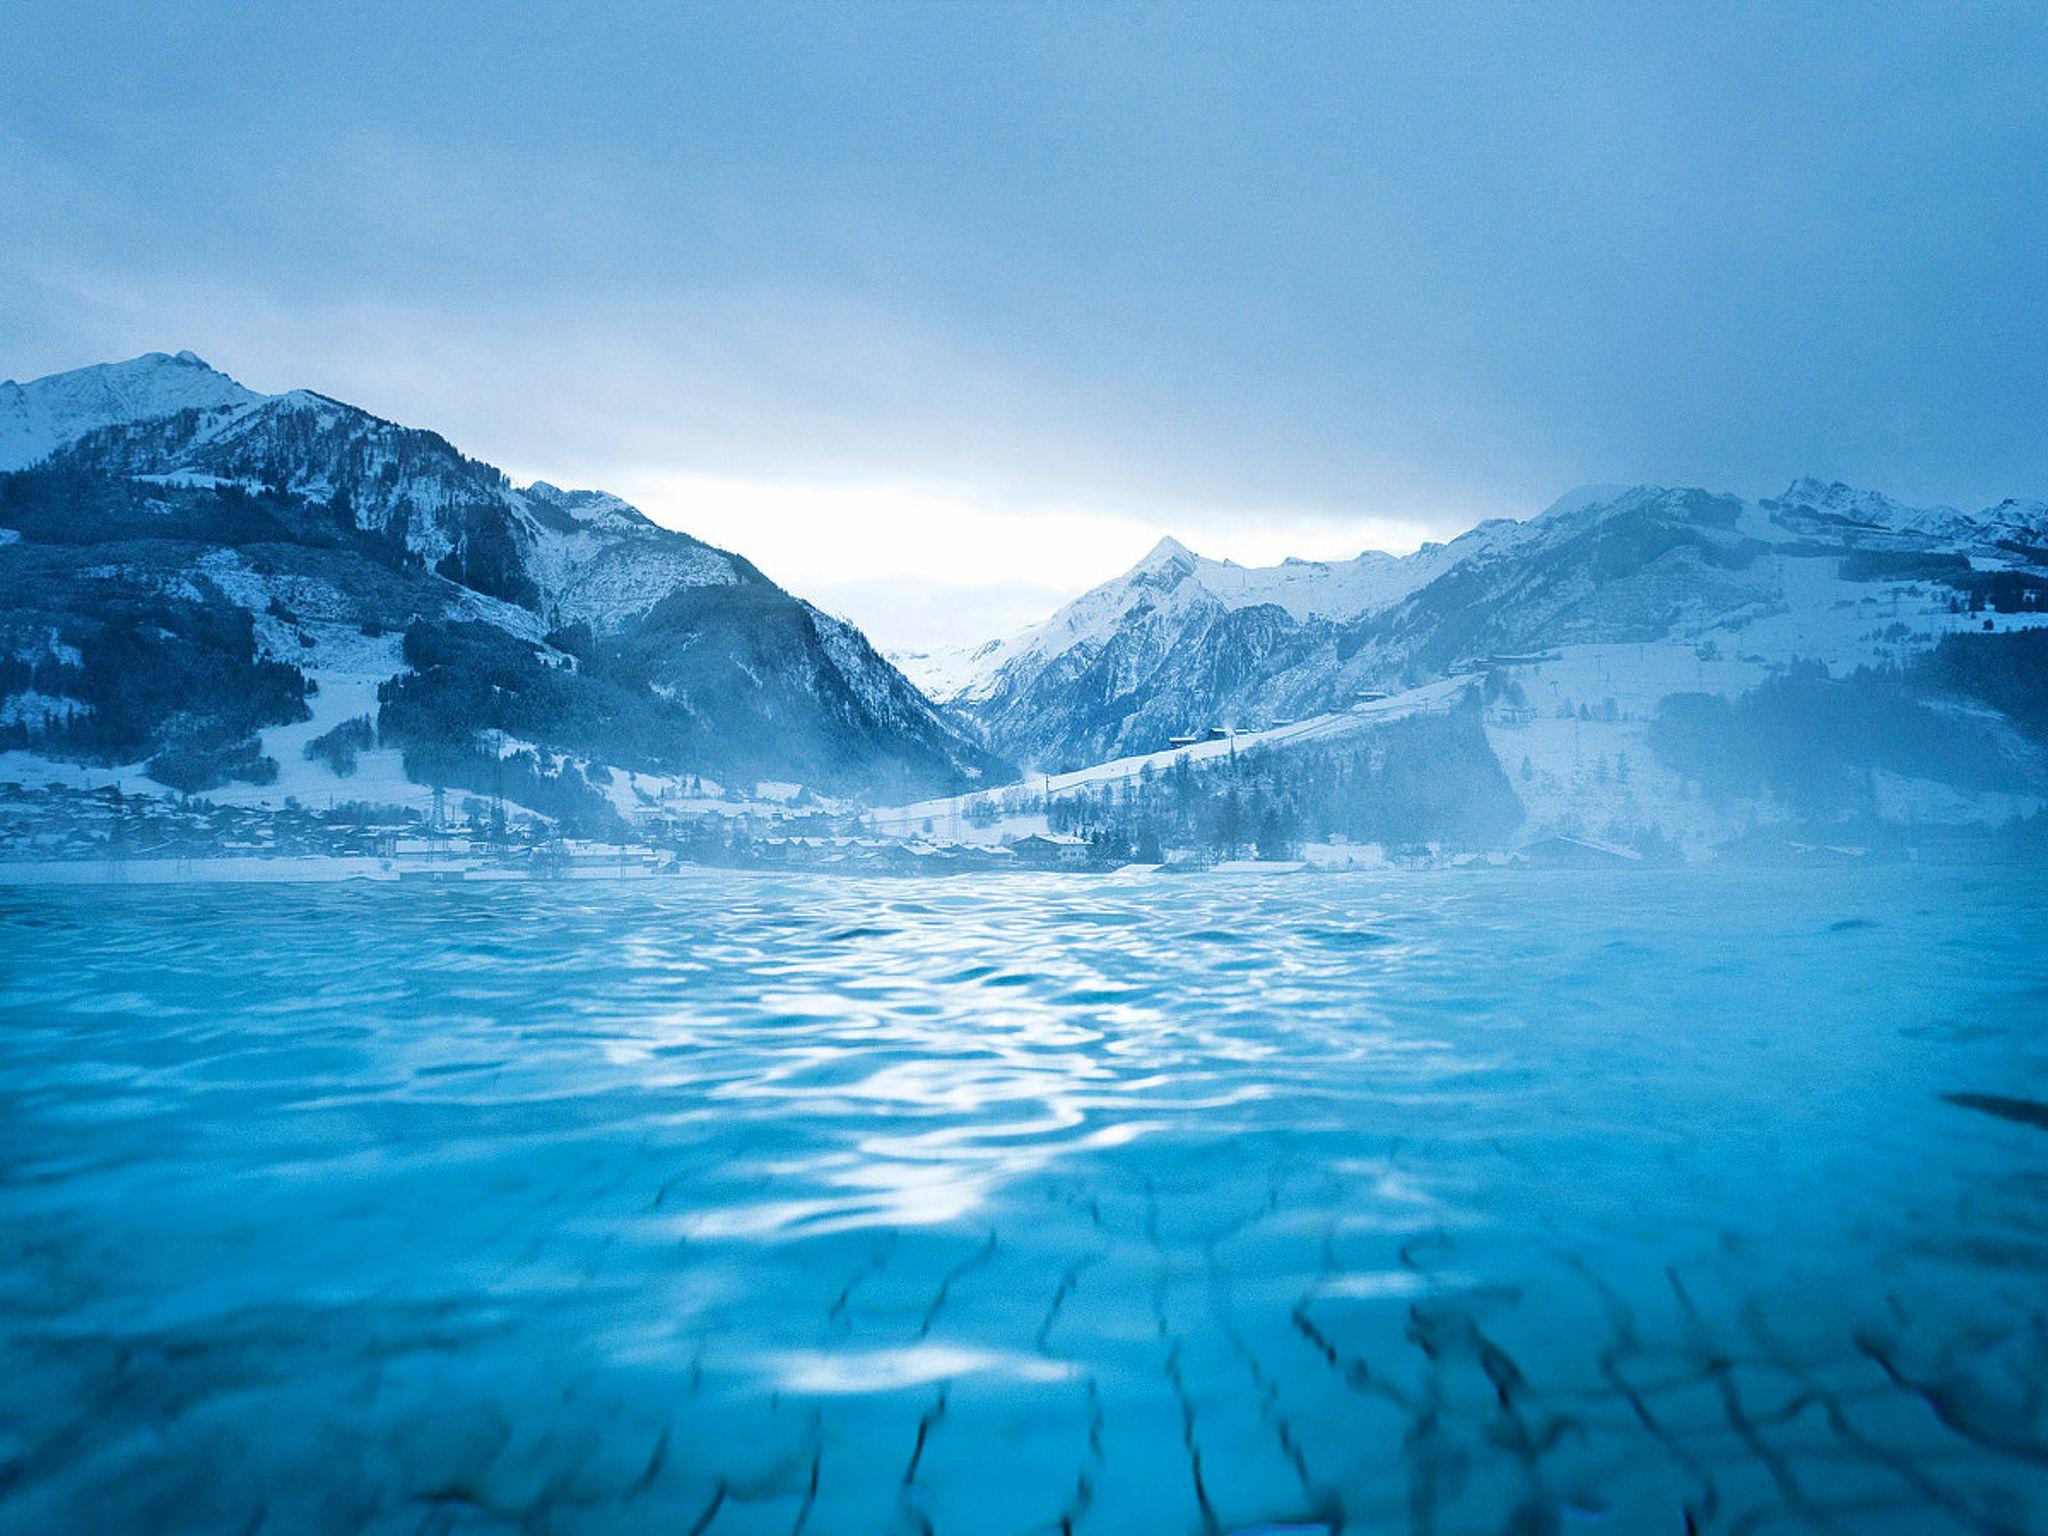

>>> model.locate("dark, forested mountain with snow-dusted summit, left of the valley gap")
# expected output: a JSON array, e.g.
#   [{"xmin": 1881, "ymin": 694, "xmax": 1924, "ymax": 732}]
[{"xmin": 0, "ymin": 352, "xmax": 1001, "ymax": 811}]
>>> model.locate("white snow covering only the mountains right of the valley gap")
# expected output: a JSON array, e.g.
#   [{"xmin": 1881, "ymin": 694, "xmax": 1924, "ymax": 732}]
[{"xmin": 934, "ymin": 479, "xmax": 2048, "ymax": 848}]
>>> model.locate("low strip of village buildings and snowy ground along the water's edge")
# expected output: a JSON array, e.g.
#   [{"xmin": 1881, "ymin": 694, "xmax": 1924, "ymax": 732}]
[{"xmin": 0, "ymin": 749, "xmax": 2009, "ymax": 883}]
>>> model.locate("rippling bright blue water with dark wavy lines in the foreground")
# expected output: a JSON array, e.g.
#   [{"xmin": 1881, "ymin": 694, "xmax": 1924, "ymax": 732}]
[{"xmin": 0, "ymin": 868, "xmax": 2048, "ymax": 1536}]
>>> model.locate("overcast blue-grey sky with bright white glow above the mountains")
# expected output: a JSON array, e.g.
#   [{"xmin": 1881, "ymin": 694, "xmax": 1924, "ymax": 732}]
[{"xmin": 0, "ymin": 0, "xmax": 2048, "ymax": 645}]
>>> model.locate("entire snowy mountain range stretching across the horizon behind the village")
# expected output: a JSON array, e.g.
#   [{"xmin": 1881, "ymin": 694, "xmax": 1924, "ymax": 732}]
[{"xmin": 0, "ymin": 352, "xmax": 2048, "ymax": 846}]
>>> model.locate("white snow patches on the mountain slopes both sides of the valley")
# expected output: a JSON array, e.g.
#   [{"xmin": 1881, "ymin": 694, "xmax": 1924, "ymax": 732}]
[{"xmin": 0, "ymin": 352, "xmax": 2048, "ymax": 840}]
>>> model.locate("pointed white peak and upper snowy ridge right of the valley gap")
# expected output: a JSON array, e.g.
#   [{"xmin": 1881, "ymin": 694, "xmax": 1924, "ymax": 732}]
[{"xmin": 940, "ymin": 479, "xmax": 2048, "ymax": 768}]
